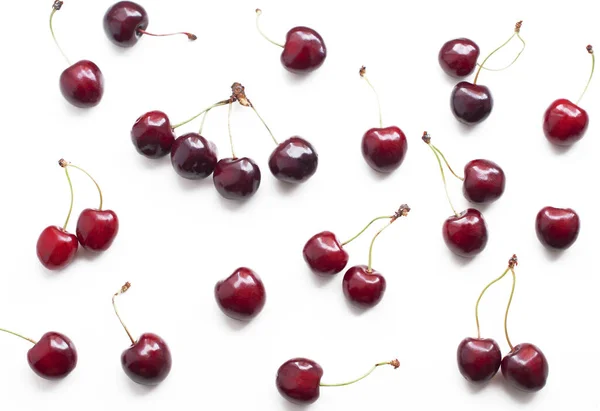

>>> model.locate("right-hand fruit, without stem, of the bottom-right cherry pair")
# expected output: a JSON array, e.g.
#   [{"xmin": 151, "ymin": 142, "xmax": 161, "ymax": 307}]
[{"xmin": 502, "ymin": 343, "xmax": 548, "ymax": 392}]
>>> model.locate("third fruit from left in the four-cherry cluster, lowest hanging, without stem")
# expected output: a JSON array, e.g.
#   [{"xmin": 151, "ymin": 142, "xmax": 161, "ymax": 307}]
[{"xmin": 213, "ymin": 157, "xmax": 260, "ymax": 200}]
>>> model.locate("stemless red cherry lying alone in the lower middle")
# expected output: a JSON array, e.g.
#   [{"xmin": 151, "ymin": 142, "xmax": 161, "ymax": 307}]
[{"xmin": 215, "ymin": 267, "xmax": 266, "ymax": 321}]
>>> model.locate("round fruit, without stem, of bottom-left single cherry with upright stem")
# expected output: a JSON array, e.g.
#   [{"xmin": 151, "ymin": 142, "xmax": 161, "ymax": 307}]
[{"xmin": 121, "ymin": 333, "xmax": 173, "ymax": 386}]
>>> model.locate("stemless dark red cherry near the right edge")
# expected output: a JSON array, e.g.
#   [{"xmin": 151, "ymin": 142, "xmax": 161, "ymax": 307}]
[{"xmin": 535, "ymin": 207, "xmax": 579, "ymax": 250}]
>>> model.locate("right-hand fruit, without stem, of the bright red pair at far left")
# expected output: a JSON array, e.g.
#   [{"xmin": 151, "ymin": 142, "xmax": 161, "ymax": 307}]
[{"xmin": 76, "ymin": 208, "xmax": 119, "ymax": 251}]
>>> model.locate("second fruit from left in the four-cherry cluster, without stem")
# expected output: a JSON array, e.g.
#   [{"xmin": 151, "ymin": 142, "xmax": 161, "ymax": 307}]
[{"xmin": 171, "ymin": 133, "xmax": 217, "ymax": 180}]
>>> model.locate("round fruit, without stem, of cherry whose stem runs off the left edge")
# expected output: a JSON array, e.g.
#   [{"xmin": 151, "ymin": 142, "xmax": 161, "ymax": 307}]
[{"xmin": 27, "ymin": 332, "xmax": 77, "ymax": 380}]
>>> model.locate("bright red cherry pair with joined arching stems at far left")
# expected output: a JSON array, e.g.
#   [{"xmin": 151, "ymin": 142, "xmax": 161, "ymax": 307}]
[{"xmin": 36, "ymin": 159, "xmax": 119, "ymax": 270}]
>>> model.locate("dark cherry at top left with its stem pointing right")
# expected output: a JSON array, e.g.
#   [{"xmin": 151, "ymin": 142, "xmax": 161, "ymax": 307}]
[{"xmin": 104, "ymin": 1, "xmax": 197, "ymax": 47}]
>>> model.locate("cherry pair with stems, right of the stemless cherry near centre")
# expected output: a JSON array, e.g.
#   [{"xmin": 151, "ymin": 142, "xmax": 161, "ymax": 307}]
[{"xmin": 302, "ymin": 204, "xmax": 410, "ymax": 308}]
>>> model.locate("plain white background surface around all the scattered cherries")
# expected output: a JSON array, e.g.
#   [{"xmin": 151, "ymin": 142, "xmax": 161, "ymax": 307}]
[{"xmin": 0, "ymin": 0, "xmax": 600, "ymax": 411}]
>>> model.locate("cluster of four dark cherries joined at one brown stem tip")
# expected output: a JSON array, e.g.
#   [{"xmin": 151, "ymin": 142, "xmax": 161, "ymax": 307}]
[{"xmin": 131, "ymin": 83, "xmax": 318, "ymax": 200}]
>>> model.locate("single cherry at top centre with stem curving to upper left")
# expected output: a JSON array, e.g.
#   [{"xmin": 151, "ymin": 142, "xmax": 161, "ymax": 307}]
[{"xmin": 256, "ymin": 9, "xmax": 327, "ymax": 74}]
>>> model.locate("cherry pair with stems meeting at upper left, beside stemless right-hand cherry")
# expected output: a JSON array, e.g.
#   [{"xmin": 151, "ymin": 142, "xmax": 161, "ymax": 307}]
[{"xmin": 422, "ymin": 132, "xmax": 506, "ymax": 257}]
